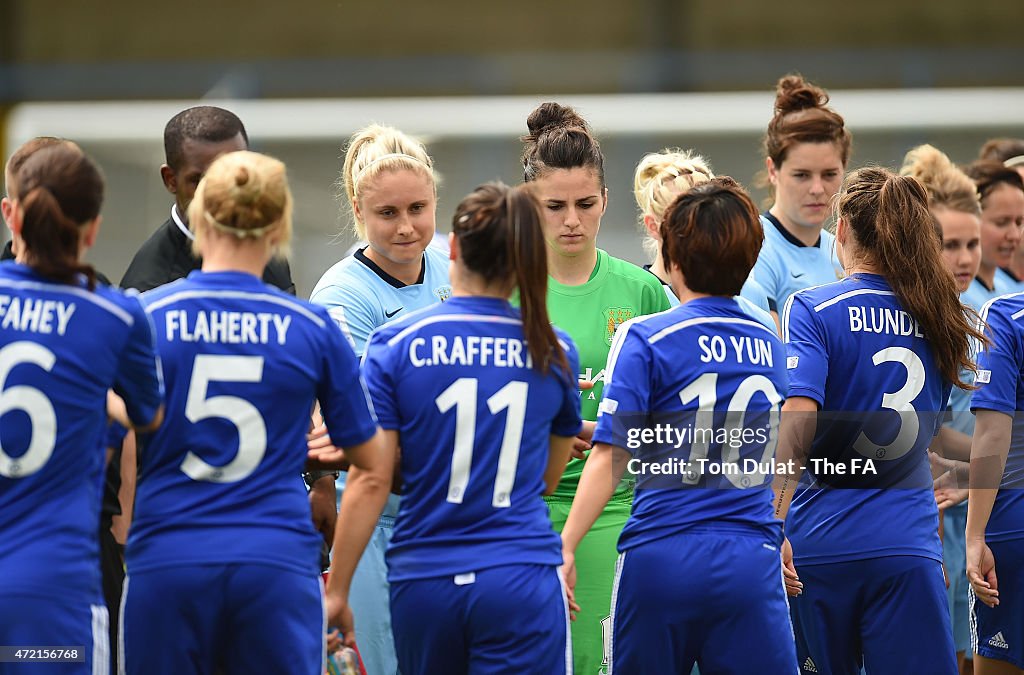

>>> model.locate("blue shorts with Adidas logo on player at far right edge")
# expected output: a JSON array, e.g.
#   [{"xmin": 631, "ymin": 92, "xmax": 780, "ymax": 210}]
[{"xmin": 971, "ymin": 539, "xmax": 1024, "ymax": 668}]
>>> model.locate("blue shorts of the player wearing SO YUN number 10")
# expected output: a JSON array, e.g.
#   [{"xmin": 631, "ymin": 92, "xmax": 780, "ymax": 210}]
[{"xmin": 609, "ymin": 526, "xmax": 797, "ymax": 675}]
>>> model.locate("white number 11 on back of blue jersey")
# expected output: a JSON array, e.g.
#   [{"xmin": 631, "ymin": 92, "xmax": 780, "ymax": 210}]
[{"xmin": 434, "ymin": 377, "xmax": 529, "ymax": 509}]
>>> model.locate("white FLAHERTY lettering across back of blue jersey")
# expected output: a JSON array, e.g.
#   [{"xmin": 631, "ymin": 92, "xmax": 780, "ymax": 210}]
[{"xmin": 164, "ymin": 309, "xmax": 292, "ymax": 344}]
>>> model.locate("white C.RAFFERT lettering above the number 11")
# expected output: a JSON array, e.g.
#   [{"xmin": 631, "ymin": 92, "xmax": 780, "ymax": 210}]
[{"xmin": 409, "ymin": 335, "xmax": 532, "ymax": 368}]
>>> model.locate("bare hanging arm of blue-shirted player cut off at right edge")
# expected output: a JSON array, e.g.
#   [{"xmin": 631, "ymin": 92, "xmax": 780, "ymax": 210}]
[{"xmin": 967, "ymin": 410, "xmax": 1013, "ymax": 607}]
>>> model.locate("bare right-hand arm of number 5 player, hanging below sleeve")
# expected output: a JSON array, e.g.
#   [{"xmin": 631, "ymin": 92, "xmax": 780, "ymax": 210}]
[{"xmin": 327, "ymin": 430, "xmax": 398, "ymax": 646}]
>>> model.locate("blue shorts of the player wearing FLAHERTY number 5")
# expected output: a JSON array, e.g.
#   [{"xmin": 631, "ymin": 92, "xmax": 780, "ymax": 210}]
[{"xmin": 119, "ymin": 563, "xmax": 327, "ymax": 675}]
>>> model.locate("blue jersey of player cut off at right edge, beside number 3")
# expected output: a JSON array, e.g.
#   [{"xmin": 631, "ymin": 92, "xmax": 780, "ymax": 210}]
[{"xmin": 971, "ymin": 293, "xmax": 1024, "ymax": 542}]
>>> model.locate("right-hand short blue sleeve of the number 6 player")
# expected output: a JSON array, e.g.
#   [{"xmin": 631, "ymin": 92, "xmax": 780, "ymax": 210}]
[{"xmin": 114, "ymin": 294, "xmax": 164, "ymax": 425}]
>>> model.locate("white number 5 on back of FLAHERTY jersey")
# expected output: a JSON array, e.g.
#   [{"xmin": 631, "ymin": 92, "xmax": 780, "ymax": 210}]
[{"xmin": 181, "ymin": 354, "xmax": 266, "ymax": 482}]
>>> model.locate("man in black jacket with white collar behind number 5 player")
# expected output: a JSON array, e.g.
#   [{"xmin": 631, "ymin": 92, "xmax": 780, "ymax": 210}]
[{"xmin": 121, "ymin": 106, "xmax": 295, "ymax": 295}]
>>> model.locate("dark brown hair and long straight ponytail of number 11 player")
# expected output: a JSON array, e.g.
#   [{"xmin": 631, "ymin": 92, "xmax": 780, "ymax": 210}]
[{"xmin": 452, "ymin": 182, "xmax": 570, "ymax": 377}]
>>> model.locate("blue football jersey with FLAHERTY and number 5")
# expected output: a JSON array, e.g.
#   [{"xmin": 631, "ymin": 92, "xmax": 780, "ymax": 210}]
[{"xmin": 127, "ymin": 271, "xmax": 377, "ymax": 574}]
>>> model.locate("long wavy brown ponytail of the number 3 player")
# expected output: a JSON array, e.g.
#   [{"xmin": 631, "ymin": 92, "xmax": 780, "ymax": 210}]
[{"xmin": 838, "ymin": 167, "xmax": 987, "ymax": 389}]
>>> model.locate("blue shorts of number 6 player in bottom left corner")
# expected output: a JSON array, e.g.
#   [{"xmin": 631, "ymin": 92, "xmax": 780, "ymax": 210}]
[{"xmin": 0, "ymin": 589, "xmax": 111, "ymax": 675}]
